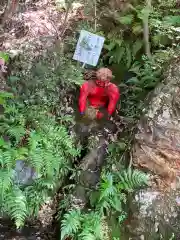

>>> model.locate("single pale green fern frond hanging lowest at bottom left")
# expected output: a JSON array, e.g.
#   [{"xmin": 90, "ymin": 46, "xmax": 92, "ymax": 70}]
[{"xmin": 5, "ymin": 187, "xmax": 27, "ymax": 228}]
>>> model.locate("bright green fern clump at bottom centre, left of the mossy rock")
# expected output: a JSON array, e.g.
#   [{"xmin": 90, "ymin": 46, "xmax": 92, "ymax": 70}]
[{"xmin": 60, "ymin": 169, "xmax": 148, "ymax": 240}]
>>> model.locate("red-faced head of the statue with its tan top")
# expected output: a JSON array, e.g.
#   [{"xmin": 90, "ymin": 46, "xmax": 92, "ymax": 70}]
[{"xmin": 96, "ymin": 68, "xmax": 112, "ymax": 87}]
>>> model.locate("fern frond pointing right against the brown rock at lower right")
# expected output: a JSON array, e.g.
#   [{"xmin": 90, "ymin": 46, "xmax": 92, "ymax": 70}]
[{"xmin": 118, "ymin": 168, "xmax": 149, "ymax": 190}]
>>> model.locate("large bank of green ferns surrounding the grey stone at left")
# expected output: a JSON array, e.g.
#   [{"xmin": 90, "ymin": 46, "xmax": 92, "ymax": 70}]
[{"xmin": 0, "ymin": 93, "xmax": 79, "ymax": 228}]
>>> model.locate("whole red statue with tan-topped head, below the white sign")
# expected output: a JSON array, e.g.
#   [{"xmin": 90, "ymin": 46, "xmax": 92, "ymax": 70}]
[{"xmin": 79, "ymin": 68, "xmax": 120, "ymax": 119}]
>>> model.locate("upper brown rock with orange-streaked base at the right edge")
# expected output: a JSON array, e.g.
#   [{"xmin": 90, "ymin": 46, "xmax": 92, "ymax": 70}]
[{"xmin": 133, "ymin": 55, "xmax": 180, "ymax": 188}]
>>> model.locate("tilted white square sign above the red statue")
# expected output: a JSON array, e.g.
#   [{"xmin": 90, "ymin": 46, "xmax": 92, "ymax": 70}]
[{"xmin": 73, "ymin": 30, "xmax": 105, "ymax": 66}]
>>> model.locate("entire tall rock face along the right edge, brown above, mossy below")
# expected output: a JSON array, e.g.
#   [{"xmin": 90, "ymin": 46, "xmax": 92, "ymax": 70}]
[{"xmin": 124, "ymin": 58, "xmax": 180, "ymax": 240}]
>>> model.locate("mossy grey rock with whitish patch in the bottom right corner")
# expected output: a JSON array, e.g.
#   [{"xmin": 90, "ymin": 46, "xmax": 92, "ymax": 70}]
[{"xmin": 122, "ymin": 189, "xmax": 180, "ymax": 240}]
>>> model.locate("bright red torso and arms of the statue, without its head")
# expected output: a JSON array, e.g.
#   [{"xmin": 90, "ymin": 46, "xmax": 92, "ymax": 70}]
[{"xmin": 79, "ymin": 81, "xmax": 120, "ymax": 115}]
